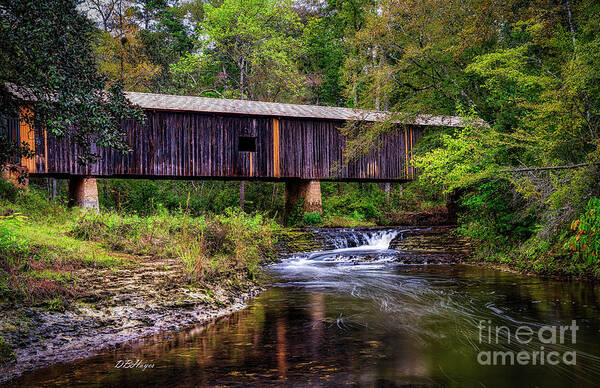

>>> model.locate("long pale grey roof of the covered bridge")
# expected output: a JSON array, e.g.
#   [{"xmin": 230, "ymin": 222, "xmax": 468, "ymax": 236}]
[{"xmin": 125, "ymin": 92, "xmax": 474, "ymax": 127}]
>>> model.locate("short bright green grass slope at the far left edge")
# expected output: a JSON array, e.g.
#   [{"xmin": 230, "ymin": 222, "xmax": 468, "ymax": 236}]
[{"xmin": 0, "ymin": 189, "xmax": 131, "ymax": 307}]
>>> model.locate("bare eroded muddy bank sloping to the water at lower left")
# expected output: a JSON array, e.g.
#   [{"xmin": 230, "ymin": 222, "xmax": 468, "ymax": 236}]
[{"xmin": 0, "ymin": 255, "xmax": 261, "ymax": 383}]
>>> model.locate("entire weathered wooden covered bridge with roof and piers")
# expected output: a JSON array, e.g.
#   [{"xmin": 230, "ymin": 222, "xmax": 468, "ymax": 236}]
[{"xmin": 3, "ymin": 92, "xmax": 463, "ymax": 208}]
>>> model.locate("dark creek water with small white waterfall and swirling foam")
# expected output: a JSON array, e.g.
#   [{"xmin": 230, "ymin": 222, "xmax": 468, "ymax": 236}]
[{"xmin": 4, "ymin": 229, "xmax": 600, "ymax": 388}]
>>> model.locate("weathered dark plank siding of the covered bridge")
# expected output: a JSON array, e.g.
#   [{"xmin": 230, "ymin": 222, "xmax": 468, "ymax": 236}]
[{"xmin": 24, "ymin": 111, "xmax": 422, "ymax": 181}]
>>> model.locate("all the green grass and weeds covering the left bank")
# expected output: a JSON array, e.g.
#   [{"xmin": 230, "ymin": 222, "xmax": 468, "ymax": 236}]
[{"xmin": 0, "ymin": 183, "xmax": 279, "ymax": 304}]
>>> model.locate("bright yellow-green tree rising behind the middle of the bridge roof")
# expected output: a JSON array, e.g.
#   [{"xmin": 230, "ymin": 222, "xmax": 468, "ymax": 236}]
[{"xmin": 172, "ymin": 0, "xmax": 306, "ymax": 102}]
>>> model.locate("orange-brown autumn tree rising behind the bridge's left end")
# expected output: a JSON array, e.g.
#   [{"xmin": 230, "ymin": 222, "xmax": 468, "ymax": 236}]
[{"xmin": 82, "ymin": 0, "xmax": 195, "ymax": 92}]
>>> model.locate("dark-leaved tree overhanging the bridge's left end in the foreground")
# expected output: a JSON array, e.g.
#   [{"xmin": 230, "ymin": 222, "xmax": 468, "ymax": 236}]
[{"xmin": 0, "ymin": 0, "xmax": 142, "ymax": 163}]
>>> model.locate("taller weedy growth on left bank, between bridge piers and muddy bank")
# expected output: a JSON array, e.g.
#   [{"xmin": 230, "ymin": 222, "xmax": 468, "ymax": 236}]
[{"xmin": 71, "ymin": 209, "xmax": 278, "ymax": 282}]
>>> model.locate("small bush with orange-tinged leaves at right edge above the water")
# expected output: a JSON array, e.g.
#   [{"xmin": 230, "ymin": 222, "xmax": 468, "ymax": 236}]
[{"xmin": 569, "ymin": 198, "xmax": 600, "ymax": 264}]
